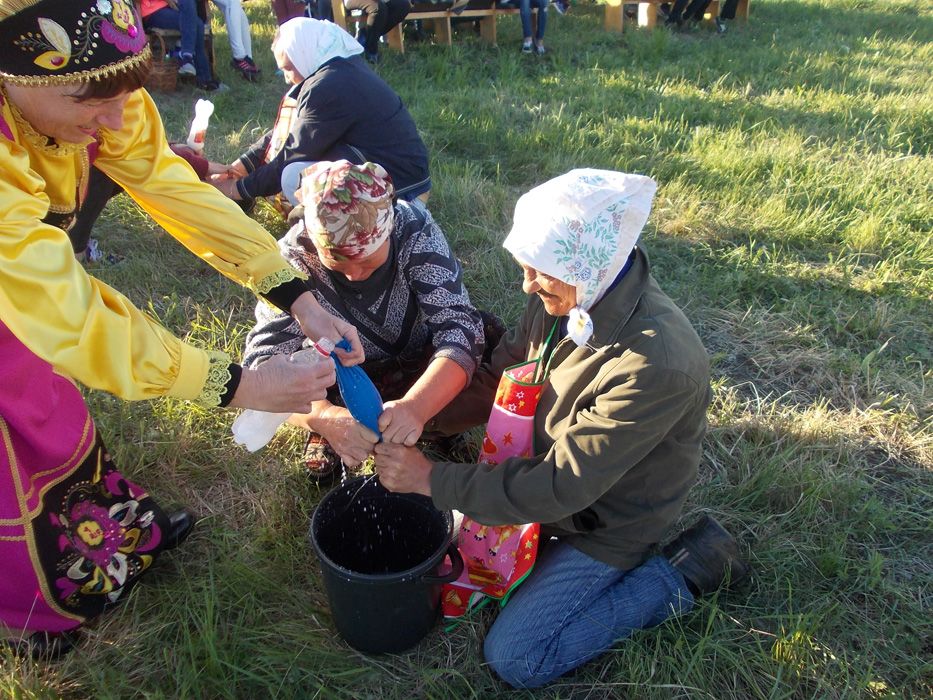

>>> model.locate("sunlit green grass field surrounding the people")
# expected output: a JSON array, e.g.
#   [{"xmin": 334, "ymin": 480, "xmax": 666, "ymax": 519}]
[{"xmin": 0, "ymin": 0, "xmax": 933, "ymax": 698}]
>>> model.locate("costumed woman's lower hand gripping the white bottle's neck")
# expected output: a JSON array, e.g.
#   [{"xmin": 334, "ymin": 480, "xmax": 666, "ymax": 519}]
[{"xmin": 229, "ymin": 355, "xmax": 337, "ymax": 413}]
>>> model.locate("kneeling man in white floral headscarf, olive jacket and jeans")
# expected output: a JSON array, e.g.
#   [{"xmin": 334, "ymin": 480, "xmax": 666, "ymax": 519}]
[{"xmin": 375, "ymin": 170, "xmax": 745, "ymax": 688}]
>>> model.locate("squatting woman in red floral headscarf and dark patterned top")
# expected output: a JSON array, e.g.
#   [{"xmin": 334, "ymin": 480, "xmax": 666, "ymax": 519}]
[{"xmin": 243, "ymin": 161, "xmax": 485, "ymax": 482}]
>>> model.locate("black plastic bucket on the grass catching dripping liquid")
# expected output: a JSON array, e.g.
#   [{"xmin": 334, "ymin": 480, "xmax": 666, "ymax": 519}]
[{"xmin": 310, "ymin": 477, "xmax": 463, "ymax": 653}]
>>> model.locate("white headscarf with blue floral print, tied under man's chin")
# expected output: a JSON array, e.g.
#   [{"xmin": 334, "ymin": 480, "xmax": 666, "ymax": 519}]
[{"xmin": 502, "ymin": 169, "xmax": 657, "ymax": 346}]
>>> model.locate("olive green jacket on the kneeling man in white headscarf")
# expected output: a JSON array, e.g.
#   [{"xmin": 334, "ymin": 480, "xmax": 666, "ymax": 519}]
[{"xmin": 431, "ymin": 250, "xmax": 711, "ymax": 570}]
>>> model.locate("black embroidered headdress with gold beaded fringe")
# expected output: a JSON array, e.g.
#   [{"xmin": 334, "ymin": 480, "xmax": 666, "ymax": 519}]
[{"xmin": 0, "ymin": 0, "xmax": 150, "ymax": 86}]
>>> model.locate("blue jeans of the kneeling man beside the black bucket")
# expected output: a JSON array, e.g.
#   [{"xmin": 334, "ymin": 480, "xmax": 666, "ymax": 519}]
[{"xmin": 483, "ymin": 541, "xmax": 693, "ymax": 688}]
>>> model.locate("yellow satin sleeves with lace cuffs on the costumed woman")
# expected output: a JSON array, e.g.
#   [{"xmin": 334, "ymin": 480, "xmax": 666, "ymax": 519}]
[{"xmin": 0, "ymin": 91, "xmax": 296, "ymax": 404}]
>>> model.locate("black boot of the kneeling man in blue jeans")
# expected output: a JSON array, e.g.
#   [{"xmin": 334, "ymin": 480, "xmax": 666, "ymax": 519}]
[{"xmin": 662, "ymin": 515, "xmax": 748, "ymax": 595}]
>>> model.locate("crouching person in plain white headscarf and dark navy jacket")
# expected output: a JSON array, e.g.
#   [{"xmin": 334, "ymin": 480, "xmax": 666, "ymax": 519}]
[{"xmin": 211, "ymin": 17, "xmax": 431, "ymax": 211}]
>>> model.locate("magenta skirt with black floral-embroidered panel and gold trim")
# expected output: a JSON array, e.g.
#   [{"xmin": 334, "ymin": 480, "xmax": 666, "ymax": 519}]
[{"xmin": 0, "ymin": 323, "xmax": 168, "ymax": 638}]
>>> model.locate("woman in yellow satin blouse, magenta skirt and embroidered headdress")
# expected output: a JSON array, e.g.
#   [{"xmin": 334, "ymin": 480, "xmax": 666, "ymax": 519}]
[{"xmin": 0, "ymin": 0, "xmax": 363, "ymax": 654}]
